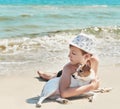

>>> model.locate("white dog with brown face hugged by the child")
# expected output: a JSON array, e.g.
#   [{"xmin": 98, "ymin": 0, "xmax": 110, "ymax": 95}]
[{"xmin": 36, "ymin": 65, "xmax": 95, "ymax": 107}]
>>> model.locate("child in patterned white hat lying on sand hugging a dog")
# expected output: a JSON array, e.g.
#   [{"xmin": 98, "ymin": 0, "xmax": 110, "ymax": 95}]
[{"xmin": 38, "ymin": 34, "xmax": 99, "ymax": 98}]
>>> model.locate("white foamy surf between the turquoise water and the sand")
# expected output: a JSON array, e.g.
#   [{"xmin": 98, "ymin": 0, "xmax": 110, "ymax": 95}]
[{"xmin": 0, "ymin": 27, "xmax": 120, "ymax": 68}]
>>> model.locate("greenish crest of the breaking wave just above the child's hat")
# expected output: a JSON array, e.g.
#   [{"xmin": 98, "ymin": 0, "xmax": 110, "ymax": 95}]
[{"xmin": 47, "ymin": 26, "xmax": 120, "ymax": 39}]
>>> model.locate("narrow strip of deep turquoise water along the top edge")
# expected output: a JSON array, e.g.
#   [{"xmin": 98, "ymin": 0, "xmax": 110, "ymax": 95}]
[{"xmin": 0, "ymin": 0, "xmax": 120, "ymax": 5}]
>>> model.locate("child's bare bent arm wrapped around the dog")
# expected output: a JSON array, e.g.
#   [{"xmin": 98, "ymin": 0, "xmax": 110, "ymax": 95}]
[{"xmin": 59, "ymin": 62, "xmax": 99, "ymax": 98}]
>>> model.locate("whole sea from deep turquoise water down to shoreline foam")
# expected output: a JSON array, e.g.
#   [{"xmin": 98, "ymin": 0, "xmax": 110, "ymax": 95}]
[{"xmin": 0, "ymin": 0, "xmax": 120, "ymax": 75}]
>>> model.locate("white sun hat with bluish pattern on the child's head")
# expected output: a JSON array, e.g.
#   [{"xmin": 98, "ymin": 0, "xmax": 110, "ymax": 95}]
[{"xmin": 69, "ymin": 33, "xmax": 96, "ymax": 54}]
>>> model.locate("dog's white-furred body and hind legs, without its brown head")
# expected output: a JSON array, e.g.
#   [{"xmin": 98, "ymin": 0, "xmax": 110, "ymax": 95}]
[{"xmin": 36, "ymin": 70, "xmax": 95, "ymax": 107}]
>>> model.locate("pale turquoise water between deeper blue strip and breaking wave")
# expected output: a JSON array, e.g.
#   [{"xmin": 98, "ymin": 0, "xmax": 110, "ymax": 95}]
[{"xmin": 0, "ymin": 5, "xmax": 120, "ymax": 38}]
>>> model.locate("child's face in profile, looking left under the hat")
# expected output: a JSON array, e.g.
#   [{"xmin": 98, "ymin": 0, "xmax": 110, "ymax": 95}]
[{"xmin": 68, "ymin": 46, "xmax": 87, "ymax": 65}]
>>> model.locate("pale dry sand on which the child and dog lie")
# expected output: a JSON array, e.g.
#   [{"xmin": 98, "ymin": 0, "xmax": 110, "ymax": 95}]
[{"xmin": 0, "ymin": 58, "xmax": 120, "ymax": 109}]
